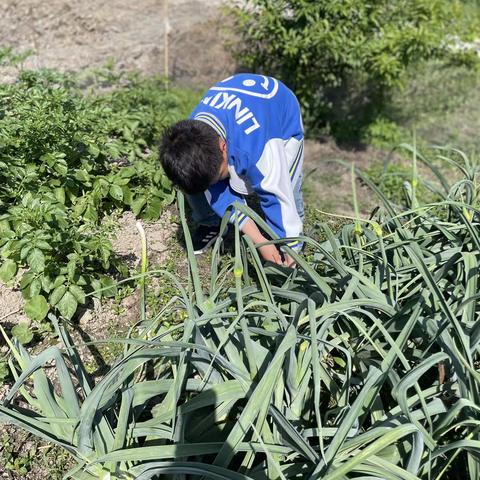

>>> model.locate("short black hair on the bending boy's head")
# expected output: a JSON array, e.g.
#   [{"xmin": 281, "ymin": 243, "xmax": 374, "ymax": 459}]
[{"xmin": 160, "ymin": 120, "xmax": 223, "ymax": 194}]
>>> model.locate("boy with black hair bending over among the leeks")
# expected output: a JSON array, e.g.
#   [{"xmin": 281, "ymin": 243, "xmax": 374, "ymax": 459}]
[{"xmin": 160, "ymin": 74, "xmax": 304, "ymax": 265}]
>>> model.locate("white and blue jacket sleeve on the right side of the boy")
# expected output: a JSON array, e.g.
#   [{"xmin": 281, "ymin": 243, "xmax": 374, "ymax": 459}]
[{"xmin": 249, "ymin": 138, "xmax": 303, "ymax": 248}]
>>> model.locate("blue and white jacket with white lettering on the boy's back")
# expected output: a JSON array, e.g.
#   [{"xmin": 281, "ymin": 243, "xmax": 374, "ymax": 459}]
[{"xmin": 190, "ymin": 74, "xmax": 303, "ymax": 248}]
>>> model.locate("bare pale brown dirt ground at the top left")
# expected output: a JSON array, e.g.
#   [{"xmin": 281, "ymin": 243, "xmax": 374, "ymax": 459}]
[{"xmin": 0, "ymin": 0, "xmax": 233, "ymax": 86}]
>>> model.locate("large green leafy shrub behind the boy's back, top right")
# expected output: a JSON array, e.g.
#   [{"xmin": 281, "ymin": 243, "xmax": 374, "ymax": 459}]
[{"xmin": 237, "ymin": 0, "xmax": 479, "ymax": 139}]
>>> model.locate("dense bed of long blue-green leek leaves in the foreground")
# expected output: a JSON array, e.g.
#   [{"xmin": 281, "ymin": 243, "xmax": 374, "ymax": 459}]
[{"xmin": 0, "ymin": 147, "xmax": 480, "ymax": 480}]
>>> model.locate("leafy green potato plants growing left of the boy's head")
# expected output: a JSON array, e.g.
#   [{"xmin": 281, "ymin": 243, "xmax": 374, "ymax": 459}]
[{"xmin": 0, "ymin": 64, "xmax": 182, "ymax": 321}]
